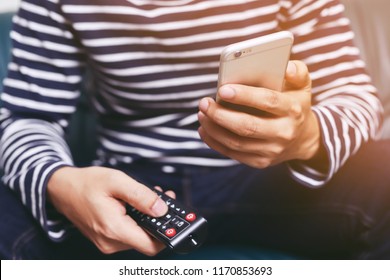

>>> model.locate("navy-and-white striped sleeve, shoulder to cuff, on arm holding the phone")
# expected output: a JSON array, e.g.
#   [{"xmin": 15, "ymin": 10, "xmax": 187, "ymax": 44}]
[{"xmin": 280, "ymin": 0, "xmax": 383, "ymax": 187}]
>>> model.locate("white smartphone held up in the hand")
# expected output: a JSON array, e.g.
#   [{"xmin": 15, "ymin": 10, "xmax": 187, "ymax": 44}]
[{"xmin": 217, "ymin": 31, "xmax": 294, "ymax": 114}]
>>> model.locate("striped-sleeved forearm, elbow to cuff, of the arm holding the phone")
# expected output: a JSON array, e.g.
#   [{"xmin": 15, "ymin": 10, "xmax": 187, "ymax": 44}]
[{"xmin": 289, "ymin": 94, "xmax": 382, "ymax": 187}]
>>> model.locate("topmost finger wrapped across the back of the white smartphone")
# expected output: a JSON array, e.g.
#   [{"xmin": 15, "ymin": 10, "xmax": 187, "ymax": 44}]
[{"xmin": 218, "ymin": 84, "xmax": 291, "ymax": 116}]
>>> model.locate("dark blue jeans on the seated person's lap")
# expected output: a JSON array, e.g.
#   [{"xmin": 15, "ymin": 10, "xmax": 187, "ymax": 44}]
[{"xmin": 0, "ymin": 141, "xmax": 390, "ymax": 259}]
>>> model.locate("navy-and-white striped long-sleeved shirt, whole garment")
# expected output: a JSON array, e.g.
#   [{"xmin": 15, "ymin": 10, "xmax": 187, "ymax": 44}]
[{"xmin": 0, "ymin": 0, "xmax": 382, "ymax": 240}]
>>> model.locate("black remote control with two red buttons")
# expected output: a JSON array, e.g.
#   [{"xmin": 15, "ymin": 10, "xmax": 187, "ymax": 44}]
[{"xmin": 127, "ymin": 190, "xmax": 207, "ymax": 254}]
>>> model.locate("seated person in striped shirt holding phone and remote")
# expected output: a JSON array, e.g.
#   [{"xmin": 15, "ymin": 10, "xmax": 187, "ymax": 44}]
[{"xmin": 1, "ymin": 0, "xmax": 388, "ymax": 258}]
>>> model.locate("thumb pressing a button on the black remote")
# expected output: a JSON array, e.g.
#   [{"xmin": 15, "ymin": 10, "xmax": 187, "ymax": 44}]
[{"xmin": 112, "ymin": 173, "xmax": 168, "ymax": 217}]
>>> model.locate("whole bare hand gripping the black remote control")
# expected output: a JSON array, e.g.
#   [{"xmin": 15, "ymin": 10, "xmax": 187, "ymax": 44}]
[{"xmin": 47, "ymin": 167, "xmax": 170, "ymax": 256}]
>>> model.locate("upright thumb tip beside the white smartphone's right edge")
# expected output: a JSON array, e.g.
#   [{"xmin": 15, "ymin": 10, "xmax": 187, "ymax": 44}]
[{"xmin": 284, "ymin": 60, "xmax": 311, "ymax": 91}]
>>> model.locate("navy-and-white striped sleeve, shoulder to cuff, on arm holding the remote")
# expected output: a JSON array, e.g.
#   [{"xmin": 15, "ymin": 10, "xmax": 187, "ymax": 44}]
[{"xmin": 0, "ymin": 0, "xmax": 84, "ymax": 241}]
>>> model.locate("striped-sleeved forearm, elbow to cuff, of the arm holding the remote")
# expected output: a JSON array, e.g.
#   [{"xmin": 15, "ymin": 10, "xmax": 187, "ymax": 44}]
[{"xmin": 0, "ymin": 118, "xmax": 73, "ymax": 240}]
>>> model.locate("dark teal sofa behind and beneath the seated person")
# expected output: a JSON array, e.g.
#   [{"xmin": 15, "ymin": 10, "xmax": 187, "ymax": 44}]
[{"xmin": 0, "ymin": 0, "xmax": 390, "ymax": 259}]
